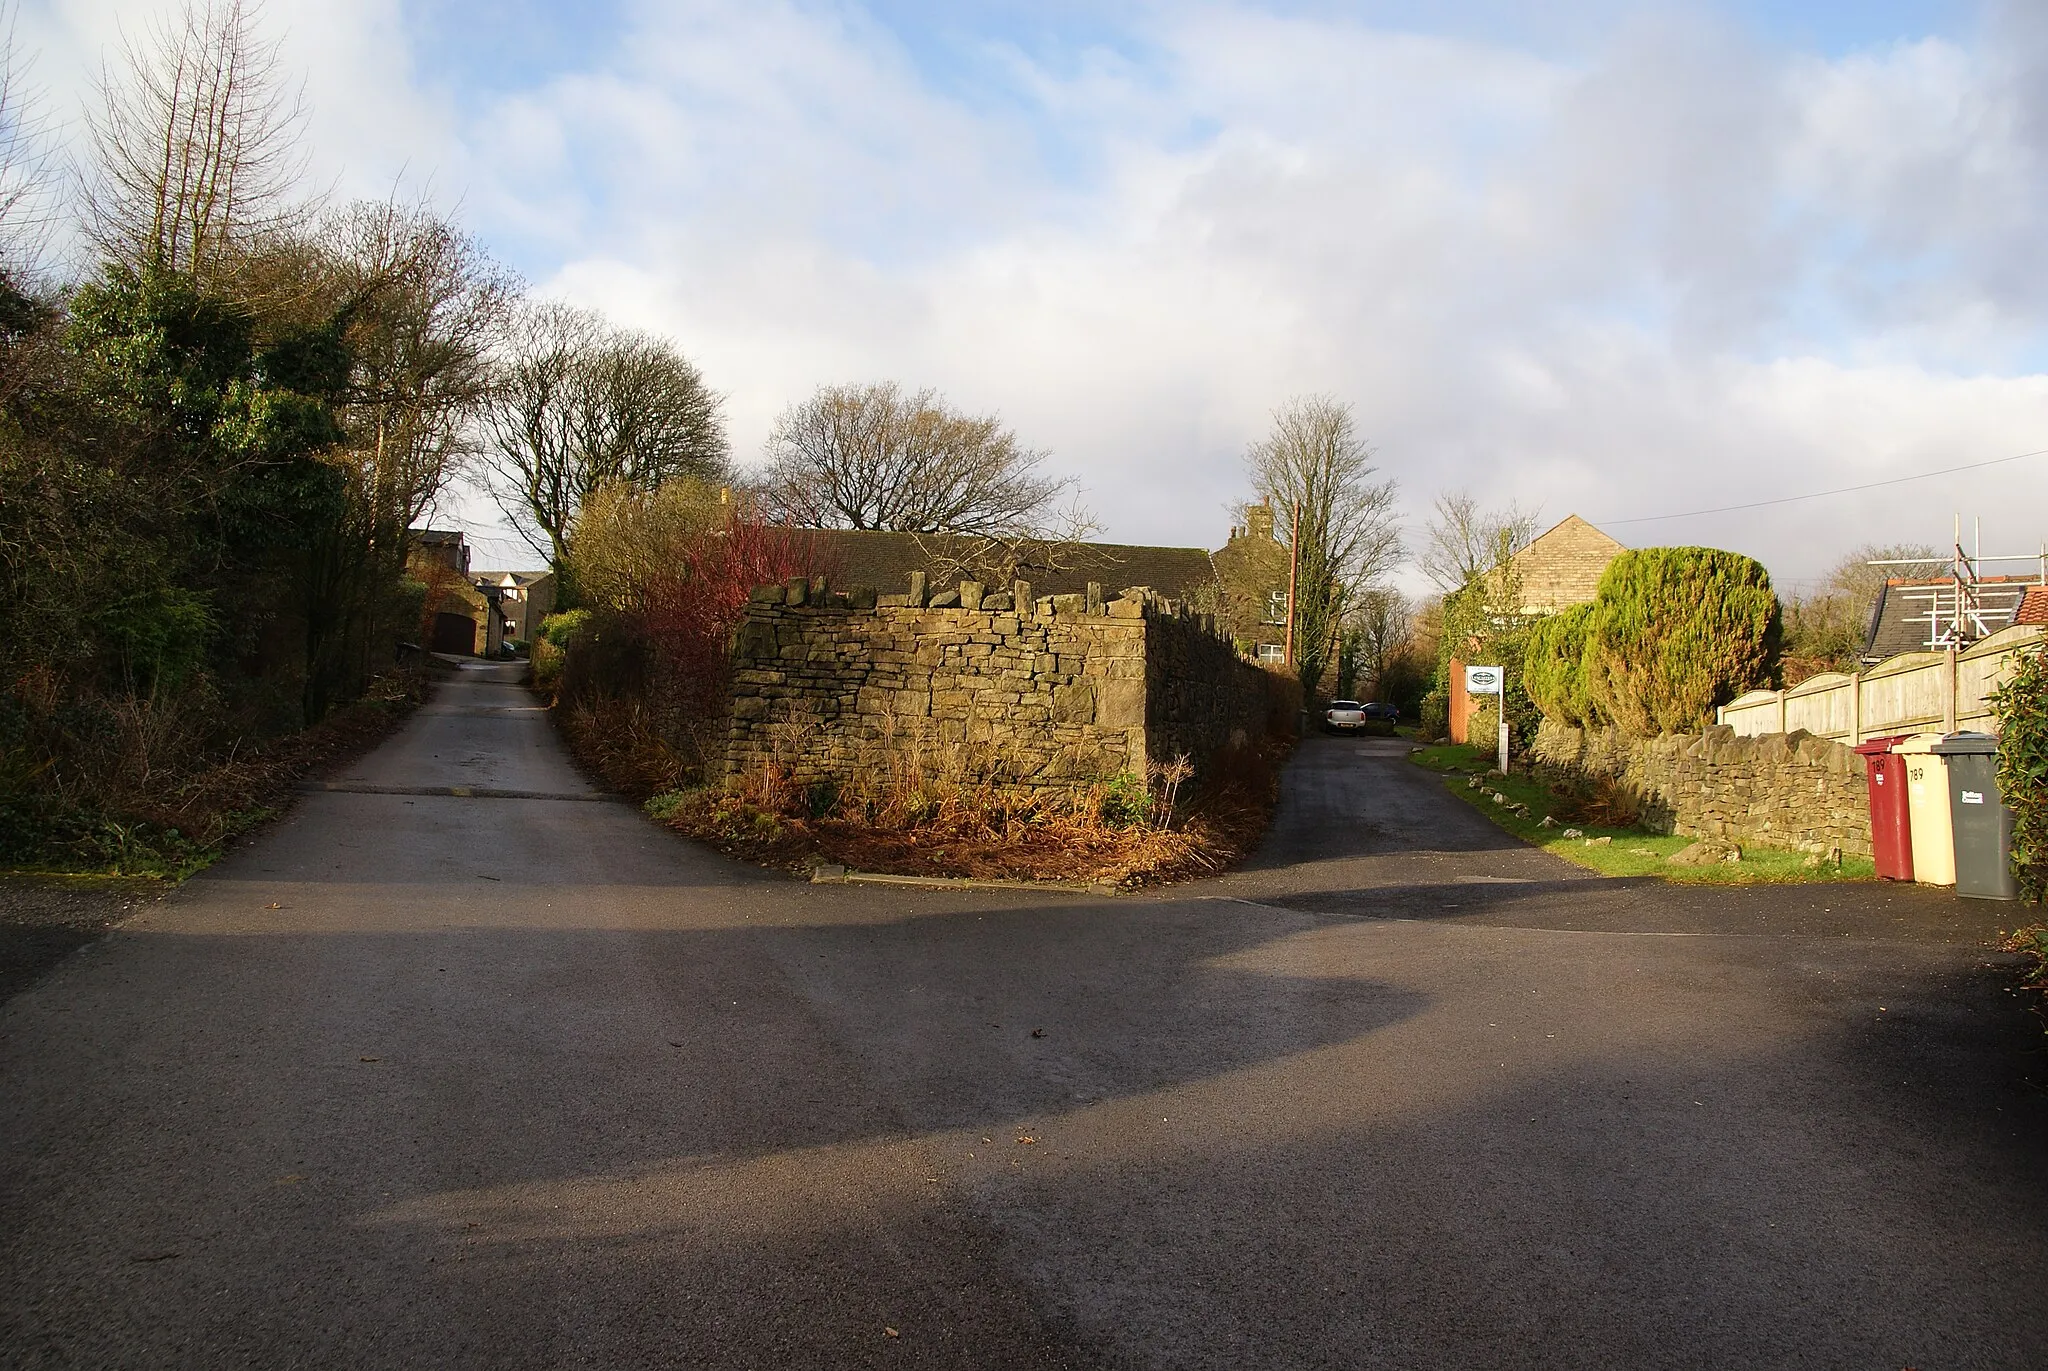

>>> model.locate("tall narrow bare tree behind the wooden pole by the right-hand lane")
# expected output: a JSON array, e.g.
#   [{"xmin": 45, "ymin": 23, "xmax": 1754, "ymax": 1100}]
[{"xmin": 1245, "ymin": 396, "xmax": 1401, "ymax": 691}]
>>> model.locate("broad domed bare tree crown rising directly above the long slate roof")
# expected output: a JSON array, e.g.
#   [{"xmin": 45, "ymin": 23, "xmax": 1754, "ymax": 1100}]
[{"xmin": 760, "ymin": 381, "xmax": 1092, "ymax": 543}]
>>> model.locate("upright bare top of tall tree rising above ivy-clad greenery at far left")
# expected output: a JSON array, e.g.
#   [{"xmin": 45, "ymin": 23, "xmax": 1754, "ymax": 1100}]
[{"xmin": 86, "ymin": 0, "xmax": 309, "ymax": 281}]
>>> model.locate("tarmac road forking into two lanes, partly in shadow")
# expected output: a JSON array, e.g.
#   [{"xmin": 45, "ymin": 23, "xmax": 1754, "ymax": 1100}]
[{"xmin": 0, "ymin": 668, "xmax": 2048, "ymax": 1369}]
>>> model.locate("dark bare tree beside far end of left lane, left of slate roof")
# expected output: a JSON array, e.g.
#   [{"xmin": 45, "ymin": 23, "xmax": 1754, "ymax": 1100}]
[{"xmin": 483, "ymin": 303, "xmax": 729, "ymax": 576}]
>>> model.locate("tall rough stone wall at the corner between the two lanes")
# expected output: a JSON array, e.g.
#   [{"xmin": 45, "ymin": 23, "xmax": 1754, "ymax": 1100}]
[{"xmin": 725, "ymin": 576, "xmax": 1270, "ymax": 789}]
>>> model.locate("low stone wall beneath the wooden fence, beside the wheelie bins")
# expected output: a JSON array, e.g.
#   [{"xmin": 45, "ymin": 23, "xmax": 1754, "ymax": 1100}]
[{"xmin": 1532, "ymin": 719, "xmax": 1870, "ymax": 857}]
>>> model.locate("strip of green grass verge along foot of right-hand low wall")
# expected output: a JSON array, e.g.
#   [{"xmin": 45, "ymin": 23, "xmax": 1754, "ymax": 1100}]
[{"xmin": 1409, "ymin": 744, "xmax": 1876, "ymax": 885}]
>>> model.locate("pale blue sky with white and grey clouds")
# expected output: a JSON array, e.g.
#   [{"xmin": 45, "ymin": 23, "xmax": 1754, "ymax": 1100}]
[{"xmin": 16, "ymin": 0, "xmax": 2048, "ymax": 590}]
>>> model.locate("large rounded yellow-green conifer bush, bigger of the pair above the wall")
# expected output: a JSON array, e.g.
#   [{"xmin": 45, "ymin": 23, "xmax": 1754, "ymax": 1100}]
[{"xmin": 1585, "ymin": 547, "xmax": 1784, "ymax": 738}]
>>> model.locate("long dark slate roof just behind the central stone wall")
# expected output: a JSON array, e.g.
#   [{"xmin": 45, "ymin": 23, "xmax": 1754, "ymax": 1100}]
[{"xmin": 803, "ymin": 529, "xmax": 1217, "ymax": 598}]
